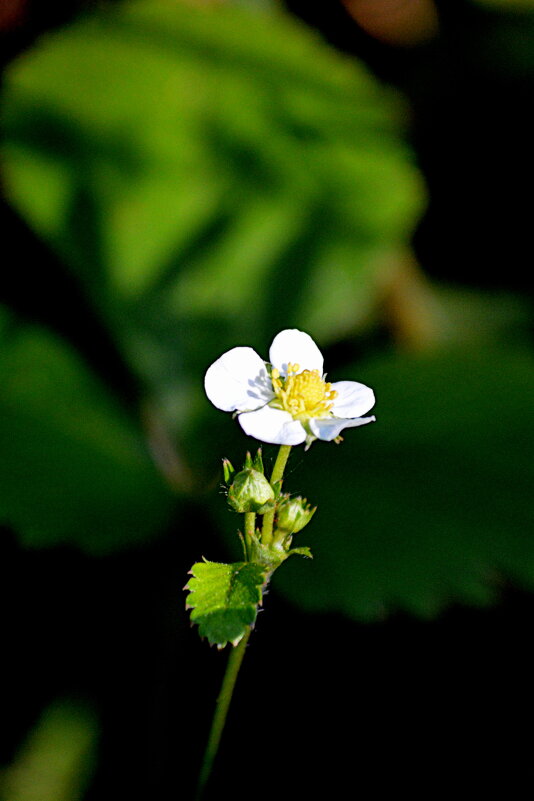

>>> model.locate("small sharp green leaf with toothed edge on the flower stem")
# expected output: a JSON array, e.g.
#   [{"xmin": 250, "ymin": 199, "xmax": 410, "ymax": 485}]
[{"xmin": 185, "ymin": 561, "xmax": 267, "ymax": 648}]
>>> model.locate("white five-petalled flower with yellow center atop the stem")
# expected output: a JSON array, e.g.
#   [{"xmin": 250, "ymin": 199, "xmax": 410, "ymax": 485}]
[{"xmin": 204, "ymin": 328, "xmax": 375, "ymax": 447}]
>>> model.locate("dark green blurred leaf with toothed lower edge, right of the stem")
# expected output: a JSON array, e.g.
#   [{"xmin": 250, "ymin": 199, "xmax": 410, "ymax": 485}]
[{"xmin": 262, "ymin": 346, "xmax": 534, "ymax": 619}]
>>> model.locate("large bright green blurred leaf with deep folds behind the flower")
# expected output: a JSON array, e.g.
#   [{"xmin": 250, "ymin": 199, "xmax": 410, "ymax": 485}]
[{"xmin": 3, "ymin": 0, "xmax": 423, "ymax": 438}]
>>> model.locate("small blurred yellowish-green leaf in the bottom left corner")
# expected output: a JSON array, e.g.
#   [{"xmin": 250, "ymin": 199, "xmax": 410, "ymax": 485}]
[{"xmin": 0, "ymin": 700, "xmax": 98, "ymax": 801}]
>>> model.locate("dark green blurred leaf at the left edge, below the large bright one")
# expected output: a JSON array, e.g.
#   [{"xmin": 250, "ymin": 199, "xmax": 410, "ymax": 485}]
[{"xmin": 0, "ymin": 308, "xmax": 172, "ymax": 553}]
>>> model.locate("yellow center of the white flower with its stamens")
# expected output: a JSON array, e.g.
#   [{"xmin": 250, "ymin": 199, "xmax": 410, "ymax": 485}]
[{"xmin": 271, "ymin": 364, "xmax": 337, "ymax": 420}]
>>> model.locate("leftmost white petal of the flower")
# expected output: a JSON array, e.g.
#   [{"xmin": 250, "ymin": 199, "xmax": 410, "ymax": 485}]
[{"xmin": 204, "ymin": 347, "xmax": 274, "ymax": 412}]
